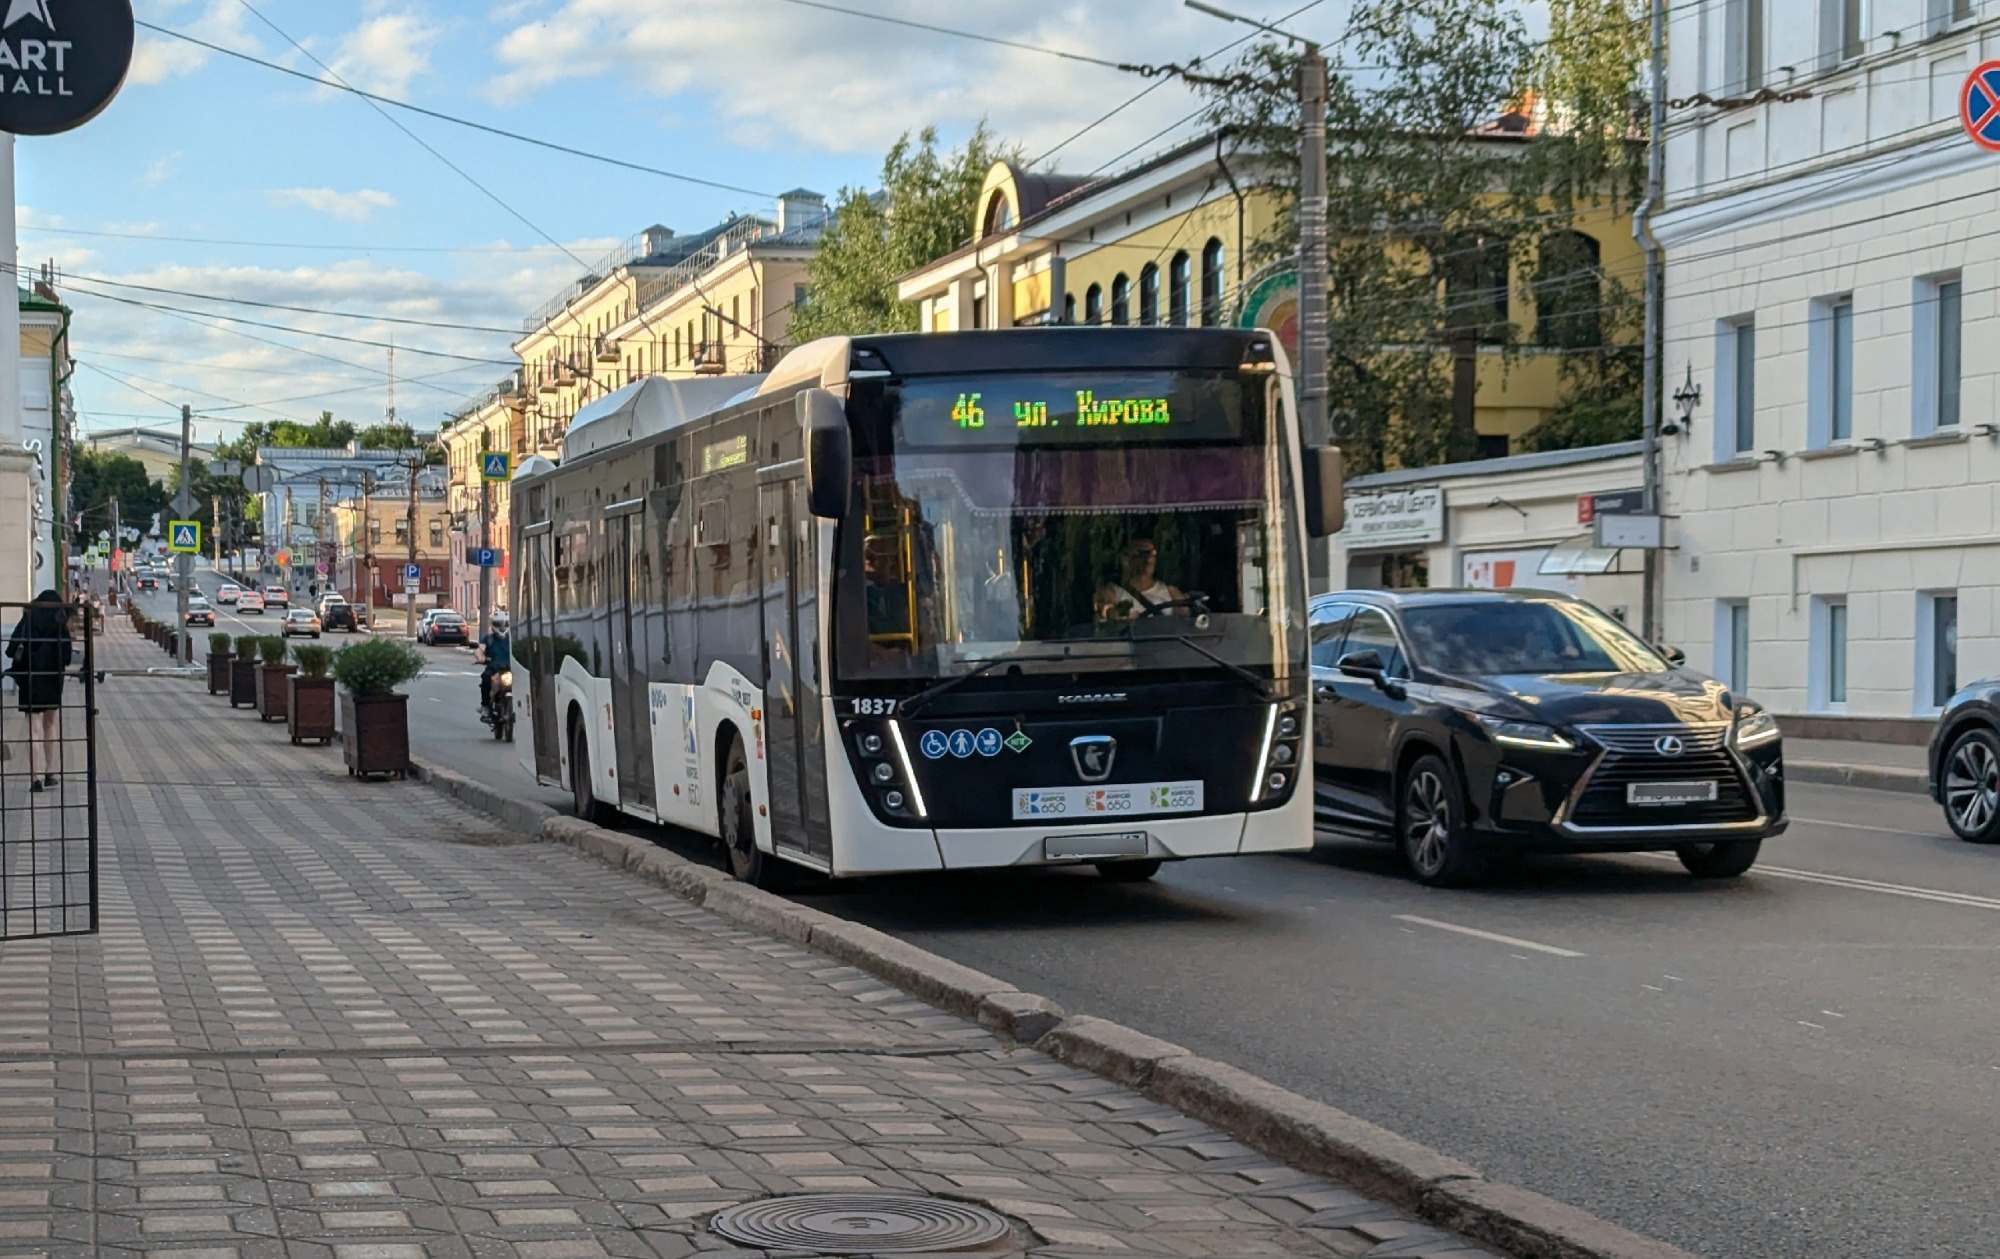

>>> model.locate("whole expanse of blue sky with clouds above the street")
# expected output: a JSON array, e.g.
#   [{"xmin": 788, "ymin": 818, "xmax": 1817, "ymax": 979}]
[{"xmin": 16, "ymin": 0, "xmax": 1346, "ymax": 449}]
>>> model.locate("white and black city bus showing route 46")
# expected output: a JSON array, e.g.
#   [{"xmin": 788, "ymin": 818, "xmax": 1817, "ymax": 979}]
[{"xmin": 512, "ymin": 328, "xmax": 1340, "ymax": 883}]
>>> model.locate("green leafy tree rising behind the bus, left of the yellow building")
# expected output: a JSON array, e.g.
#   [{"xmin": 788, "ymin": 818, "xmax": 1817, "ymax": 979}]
[{"xmin": 792, "ymin": 124, "xmax": 1020, "ymax": 344}]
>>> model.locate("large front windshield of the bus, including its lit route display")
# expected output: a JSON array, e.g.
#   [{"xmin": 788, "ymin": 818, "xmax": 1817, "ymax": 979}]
[{"xmin": 834, "ymin": 370, "xmax": 1304, "ymax": 681}]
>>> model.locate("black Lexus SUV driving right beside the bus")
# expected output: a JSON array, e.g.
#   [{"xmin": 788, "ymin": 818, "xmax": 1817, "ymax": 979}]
[{"xmin": 1310, "ymin": 590, "xmax": 1786, "ymax": 885}]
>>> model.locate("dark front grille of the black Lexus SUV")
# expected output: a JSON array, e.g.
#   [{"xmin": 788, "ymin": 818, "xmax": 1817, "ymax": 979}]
[{"xmin": 1568, "ymin": 725, "xmax": 1760, "ymax": 829}]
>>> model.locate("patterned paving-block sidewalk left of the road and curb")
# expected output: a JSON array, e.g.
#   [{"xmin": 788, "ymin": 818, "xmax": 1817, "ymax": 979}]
[{"xmin": 0, "ymin": 628, "xmax": 1484, "ymax": 1259}]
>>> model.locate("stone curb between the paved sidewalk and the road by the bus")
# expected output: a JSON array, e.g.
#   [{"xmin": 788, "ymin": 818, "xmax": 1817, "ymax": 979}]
[{"xmin": 416, "ymin": 765, "xmax": 1696, "ymax": 1259}]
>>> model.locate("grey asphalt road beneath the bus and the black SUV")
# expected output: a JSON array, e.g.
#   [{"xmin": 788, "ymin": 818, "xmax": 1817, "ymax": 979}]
[{"xmin": 133, "ymin": 571, "xmax": 2000, "ymax": 1259}]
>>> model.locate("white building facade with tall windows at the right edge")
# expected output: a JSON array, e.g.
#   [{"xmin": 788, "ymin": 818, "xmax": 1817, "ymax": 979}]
[{"xmin": 1654, "ymin": 0, "xmax": 2000, "ymax": 719}]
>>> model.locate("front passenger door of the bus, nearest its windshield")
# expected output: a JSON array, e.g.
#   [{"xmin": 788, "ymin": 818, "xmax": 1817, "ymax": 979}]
[{"xmin": 758, "ymin": 480, "xmax": 830, "ymax": 857}]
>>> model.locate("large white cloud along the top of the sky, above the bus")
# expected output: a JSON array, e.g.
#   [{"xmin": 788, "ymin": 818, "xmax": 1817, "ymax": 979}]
[{"xmin": 486, "ymin": 0, "xmax": 1346, "ymax": 170}]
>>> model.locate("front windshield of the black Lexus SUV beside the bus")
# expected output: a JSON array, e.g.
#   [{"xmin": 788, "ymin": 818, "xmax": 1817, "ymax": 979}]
[{"xmin": 1402, "ymin": 600, "xmax": 1672, "ymax": 677}]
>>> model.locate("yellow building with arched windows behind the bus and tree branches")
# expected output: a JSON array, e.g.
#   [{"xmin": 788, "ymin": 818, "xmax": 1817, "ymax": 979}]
[{"xmin": 898, "ymin": 136, "xmax": 1640, "ymax": 456}]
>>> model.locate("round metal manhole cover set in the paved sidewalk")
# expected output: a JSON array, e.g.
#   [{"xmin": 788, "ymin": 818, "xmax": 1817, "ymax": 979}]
[{"xmin": 708, "ymin": 1193, "xmax": 1008, "ymax": 1255}]
